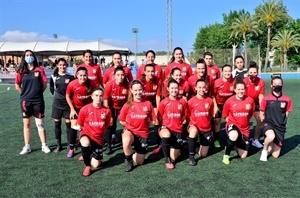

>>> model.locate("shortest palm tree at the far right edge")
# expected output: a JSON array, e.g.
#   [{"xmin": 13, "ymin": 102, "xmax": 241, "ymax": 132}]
[{"xmin": 271, "ymin": 30, "xmax": 300, "ymax": 71}]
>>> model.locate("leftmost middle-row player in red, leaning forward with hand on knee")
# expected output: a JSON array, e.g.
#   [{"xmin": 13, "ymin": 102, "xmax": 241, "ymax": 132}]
[{"xmin": 66, "ymin": 67, "xmax": 97, "ymax": 158}]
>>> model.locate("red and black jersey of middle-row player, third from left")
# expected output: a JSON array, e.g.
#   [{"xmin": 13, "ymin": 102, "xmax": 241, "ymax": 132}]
[{"xmin": 141, "ymin": 76, "xmax": 162, "ymax": 102}]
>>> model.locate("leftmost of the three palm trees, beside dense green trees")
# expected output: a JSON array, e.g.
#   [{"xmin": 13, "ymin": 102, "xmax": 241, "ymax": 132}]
[{"xmin": 230, "ymin": 13, "xmax": 261, "ymax": 65}]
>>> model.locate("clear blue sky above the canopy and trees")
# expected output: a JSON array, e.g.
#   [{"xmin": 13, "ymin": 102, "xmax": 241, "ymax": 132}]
[{"xmin": 0, "ymin": 0, "xmax": 300, "ymax": 52}]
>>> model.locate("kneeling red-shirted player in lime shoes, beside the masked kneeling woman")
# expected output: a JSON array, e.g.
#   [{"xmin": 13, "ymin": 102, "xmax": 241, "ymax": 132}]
[{"xmin": 222, "ymin": 78, "xmax": 255, "ymax": 164}]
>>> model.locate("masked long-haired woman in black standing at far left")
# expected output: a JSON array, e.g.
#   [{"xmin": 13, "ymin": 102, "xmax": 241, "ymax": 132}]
[{"xmin": 15, "ymin": 50, "xmax": 51, "ymax": 155}]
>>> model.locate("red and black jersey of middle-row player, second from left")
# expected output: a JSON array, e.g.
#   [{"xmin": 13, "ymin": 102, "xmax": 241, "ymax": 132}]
[{"xmin": 103, "ymin": 80, "xmax": 129, "ymax": 109}]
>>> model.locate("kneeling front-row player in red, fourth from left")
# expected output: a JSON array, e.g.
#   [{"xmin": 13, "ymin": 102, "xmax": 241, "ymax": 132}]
[{"xmin": 188, "ymin": 79, "xmax": 214, "ymax": 166}]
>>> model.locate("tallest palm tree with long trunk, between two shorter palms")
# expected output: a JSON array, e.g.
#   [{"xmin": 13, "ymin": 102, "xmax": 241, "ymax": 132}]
[{"xmin": 255, "ymin": 0, "xmax": 290, "ymax": 72}]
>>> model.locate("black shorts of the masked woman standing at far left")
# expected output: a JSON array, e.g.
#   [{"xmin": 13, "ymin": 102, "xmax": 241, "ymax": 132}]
[{"xmin": 20, "ymin": 100, "xmax": 45, "ymax": 118}]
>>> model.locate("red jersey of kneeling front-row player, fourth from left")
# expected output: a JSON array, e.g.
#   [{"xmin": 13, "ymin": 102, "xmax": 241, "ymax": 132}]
[{"xmin": 188, "ymin": 96, "xmax": 214, "ymax": 132}]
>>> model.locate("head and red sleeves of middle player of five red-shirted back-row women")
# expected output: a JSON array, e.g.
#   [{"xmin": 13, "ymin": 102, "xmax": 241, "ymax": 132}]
[{"xmin": 136, "ymin": 50, "xmax": 164, "ymax": 81}]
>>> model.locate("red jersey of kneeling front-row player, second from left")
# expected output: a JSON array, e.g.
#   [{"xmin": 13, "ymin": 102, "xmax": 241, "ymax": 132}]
[{"xmin": 119, "ymin": 101, "xmax": 156, "ymax": 138}]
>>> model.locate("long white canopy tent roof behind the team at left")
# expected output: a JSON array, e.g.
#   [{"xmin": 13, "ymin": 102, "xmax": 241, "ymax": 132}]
[{"xmin": 0, "ymin": 41, "xmax": 131, "ymax": 56}]
